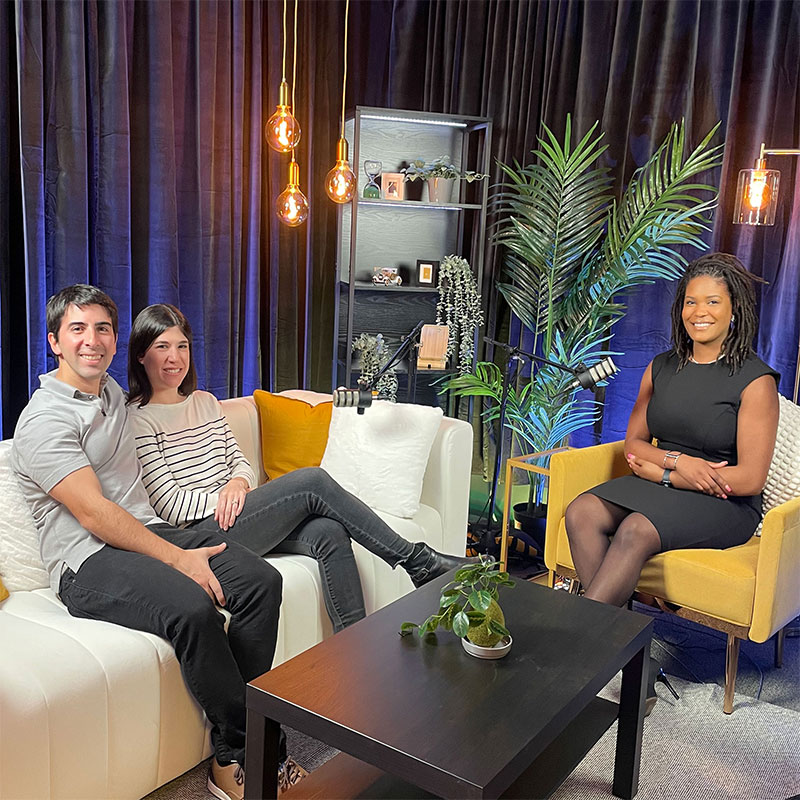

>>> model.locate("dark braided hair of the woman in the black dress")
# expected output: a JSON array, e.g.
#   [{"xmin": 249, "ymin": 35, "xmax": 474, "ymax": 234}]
[{"xmin": 670, "ymin": 253, "xmax": 766, "ymax": 375}]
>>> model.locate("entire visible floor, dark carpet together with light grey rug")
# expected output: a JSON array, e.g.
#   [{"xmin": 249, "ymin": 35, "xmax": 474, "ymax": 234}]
[{"xmin": 147, "ymin": 605, "xmax": 800, "ymax": 800}]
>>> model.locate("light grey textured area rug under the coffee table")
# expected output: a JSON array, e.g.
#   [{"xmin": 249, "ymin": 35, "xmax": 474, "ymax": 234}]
[{"xmin": 148, "ymin": 678, "xmax": 800, "ymax": 800}]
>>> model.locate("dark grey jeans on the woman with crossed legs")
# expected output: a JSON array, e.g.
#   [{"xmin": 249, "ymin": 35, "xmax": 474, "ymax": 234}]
[{"xmin": 191, "ymin": 467, "xmax": 413, "ymax": 631}]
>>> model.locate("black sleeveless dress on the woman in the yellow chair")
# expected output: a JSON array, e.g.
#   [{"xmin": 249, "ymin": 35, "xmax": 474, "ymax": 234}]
[{"xmin": 589, "ymin": 351, "xmax": 780, "ymax": 552}]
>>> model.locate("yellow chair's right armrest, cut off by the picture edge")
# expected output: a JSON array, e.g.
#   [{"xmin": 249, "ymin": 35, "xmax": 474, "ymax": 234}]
[{"xmin": 750, "ymin": 497, "xmax": 800, "ymax": 642}]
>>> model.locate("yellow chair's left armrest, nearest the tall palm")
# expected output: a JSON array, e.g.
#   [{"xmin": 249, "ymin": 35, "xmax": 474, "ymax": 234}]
[{"xmin": 544, "ymin": 442, "xmax": 629, "ymax": 570}]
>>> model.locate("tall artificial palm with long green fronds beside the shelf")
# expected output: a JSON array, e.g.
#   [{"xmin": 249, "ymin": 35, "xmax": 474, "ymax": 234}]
[{"xmin": 447, "ymin": 116, "xmax": 723, "ymax": 520}]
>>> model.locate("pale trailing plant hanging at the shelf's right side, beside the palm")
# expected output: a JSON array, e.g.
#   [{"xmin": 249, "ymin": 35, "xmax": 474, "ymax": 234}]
[{"xmin": 436, "ymin": 255, "xmax": 483, "ymax": 375}]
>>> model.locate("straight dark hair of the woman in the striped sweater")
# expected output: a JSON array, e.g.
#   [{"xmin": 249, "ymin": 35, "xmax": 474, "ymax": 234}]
[{"xmin": 128, "ymin": 303, "xmax": 197, "ymax": 408}]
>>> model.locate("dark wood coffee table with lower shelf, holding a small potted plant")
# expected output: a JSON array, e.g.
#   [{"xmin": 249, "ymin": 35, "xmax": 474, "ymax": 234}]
[{"xmin": 245, "ymin": 576, "xmax": 653, "ymax": 800}]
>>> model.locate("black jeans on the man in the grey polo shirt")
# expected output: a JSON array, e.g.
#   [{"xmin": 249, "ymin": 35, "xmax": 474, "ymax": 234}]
[{"xmin": 59, "ymin": 525, "xmax": 281, "ymax": 764}]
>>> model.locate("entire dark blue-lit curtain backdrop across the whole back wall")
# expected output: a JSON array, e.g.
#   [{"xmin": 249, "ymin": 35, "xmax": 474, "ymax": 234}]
[{"xmin": 0, "ymin": 0, "xmax": 800, "ymax": 441}]
